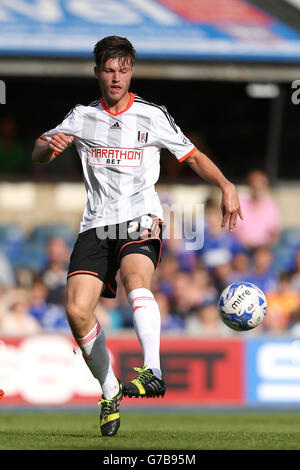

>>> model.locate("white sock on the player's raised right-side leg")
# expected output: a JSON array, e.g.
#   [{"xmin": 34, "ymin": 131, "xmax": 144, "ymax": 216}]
[{"xmin": 128, "ymin": 288, "xmax": 162, "ymax": 379}]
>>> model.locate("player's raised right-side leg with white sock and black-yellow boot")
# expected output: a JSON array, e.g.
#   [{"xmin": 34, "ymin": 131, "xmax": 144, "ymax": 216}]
[{"xmin": 120, "ymin": 252, "xmax": 166, "ymax": 397}]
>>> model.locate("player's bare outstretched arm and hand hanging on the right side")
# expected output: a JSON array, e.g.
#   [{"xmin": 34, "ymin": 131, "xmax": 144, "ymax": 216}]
[{"xmin": 185, "ymin": 150, "xmax": 243, "ymax": 231}]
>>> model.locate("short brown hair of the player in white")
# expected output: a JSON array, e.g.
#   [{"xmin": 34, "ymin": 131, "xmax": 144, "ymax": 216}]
[{"xmin": 94, "ymin": 36, "xmax": 135, "ymax": 67}]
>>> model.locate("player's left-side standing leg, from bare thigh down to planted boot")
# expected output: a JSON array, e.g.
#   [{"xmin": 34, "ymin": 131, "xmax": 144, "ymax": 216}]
[{"xmin": 66, "ymin": 274, "xmax": 122, "ymax": 436}]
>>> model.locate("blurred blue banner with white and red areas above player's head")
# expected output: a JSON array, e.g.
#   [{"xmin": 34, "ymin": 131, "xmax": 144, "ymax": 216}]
[{"xmin": 0, "ymin": 0, "xmax": 300, "ymax": 61}]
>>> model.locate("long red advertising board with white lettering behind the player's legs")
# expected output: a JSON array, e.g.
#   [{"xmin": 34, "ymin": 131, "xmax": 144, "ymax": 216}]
[{"xmin": 0, "ymin": 335, "xmax": 245, "ymax": 407}]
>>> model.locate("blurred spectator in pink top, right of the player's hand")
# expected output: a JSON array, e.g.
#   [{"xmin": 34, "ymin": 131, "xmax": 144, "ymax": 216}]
[{"xmin": 235, "ymin": 170, "xmax": 281, "ymax": 248}]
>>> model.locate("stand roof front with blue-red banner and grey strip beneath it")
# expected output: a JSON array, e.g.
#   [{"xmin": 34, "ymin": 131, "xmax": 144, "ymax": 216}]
[{"xmin": 0, "ymin": 0, "xmax": 300, "ymax": 81}]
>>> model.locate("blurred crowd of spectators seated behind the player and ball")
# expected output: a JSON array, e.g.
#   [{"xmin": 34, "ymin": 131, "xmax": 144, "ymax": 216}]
[{"xmin": 0, "ymin": 170, "xmax": 300, "ymax": 337}]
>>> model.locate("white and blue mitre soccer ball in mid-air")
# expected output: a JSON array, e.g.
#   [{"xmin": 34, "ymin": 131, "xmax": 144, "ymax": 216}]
[{"xmin": 218, "ymin": 282, "xmax": 267, "ymax": 331}]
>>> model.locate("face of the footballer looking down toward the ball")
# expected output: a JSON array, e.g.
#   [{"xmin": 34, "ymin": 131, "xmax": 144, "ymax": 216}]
[{"xmin": 95, "ymin": 57, "xmax": 133, "ymax": 103}]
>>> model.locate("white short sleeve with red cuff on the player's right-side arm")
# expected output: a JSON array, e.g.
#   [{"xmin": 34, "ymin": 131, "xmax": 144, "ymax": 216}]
[{"xmin": 155, "ymin": 106, "xmax": 197, "ymax": 162}]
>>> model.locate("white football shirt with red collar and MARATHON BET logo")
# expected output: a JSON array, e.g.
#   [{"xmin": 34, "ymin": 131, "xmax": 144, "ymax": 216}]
[{"xmin": 41, "ymin": 93, "xmax": 196, "ymax": 232}]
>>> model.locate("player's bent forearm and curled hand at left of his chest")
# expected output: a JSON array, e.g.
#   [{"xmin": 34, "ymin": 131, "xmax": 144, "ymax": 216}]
[{"xmin": 32, "ymin": 132, "xmax": 74, "ymax": 164}]
